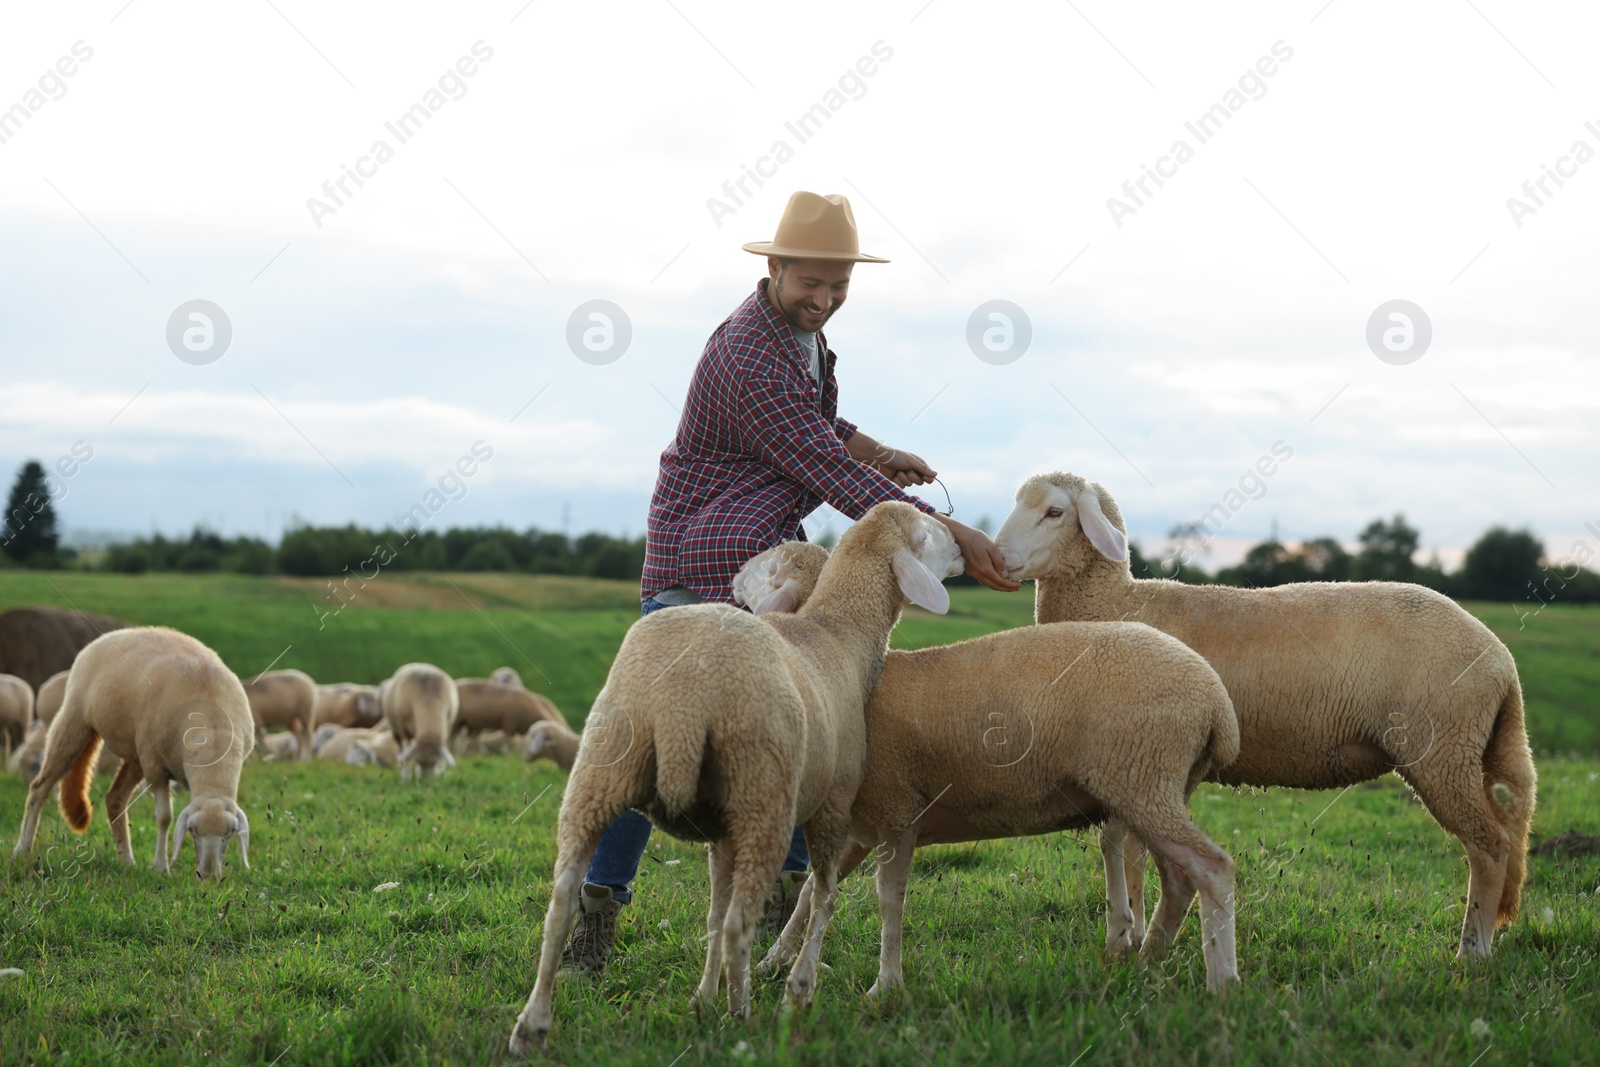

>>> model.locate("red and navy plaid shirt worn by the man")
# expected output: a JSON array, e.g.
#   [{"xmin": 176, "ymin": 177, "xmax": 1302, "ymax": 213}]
[{"xmin": 640, "ymin": 278, "xmax": 934, "ymax": 603}]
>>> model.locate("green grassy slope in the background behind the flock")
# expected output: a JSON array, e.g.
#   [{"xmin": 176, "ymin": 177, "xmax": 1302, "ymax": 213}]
[{"xmin": 0, "ymin": 571, "xmax": 1600, "ymax": 755}]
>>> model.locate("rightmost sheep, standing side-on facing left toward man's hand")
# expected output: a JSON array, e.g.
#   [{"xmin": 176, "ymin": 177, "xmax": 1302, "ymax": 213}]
[{"xmin": 997, "ymin": 472, "xmax": 1538, "ymax": 958}]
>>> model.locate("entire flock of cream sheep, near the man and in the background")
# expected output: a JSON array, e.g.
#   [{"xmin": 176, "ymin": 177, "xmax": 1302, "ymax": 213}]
[{"xmin": 0, "ymin": 474, "xmax": 1536, "ymax": 1053}]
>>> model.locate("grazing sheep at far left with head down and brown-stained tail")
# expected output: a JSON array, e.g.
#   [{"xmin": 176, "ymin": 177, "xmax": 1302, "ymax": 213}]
[{"xmin": 14, "ymin": 627, "xmax": 254, "ymax": 878}]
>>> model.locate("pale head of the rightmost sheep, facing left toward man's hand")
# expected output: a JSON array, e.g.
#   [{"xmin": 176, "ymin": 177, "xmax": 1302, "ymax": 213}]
[{"xmin": 995, "ymin": 470, "xmax": 1128, "ymax": 581}]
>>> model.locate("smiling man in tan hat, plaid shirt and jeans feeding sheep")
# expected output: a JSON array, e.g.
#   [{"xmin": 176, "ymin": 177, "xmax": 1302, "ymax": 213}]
[{"xmin": 562, "ymin": 192, "xmax": 1019, "ymax": 973}]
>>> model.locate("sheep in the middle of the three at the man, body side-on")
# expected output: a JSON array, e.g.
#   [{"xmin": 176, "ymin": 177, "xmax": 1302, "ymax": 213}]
[{"xmin": 733, "ymin": 541, "xmax": 1238, "ymax": 998}]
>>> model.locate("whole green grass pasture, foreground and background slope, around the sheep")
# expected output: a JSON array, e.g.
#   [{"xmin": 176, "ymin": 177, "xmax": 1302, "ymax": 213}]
[{"xmin": 0, "ymin": 573, "xmax": 1600, "ymax": 1067}]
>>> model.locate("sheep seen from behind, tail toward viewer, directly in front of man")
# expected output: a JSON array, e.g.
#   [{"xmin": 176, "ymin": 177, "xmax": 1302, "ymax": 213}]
[{"xmin": 510, "ymin": 501, "xmax": 960, "ymax": 1054}]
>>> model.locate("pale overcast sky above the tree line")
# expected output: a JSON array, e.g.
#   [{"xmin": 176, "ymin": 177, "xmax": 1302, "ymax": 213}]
[{"xmin": 0, "ymin": 0, "xmax": 1600, "ymax": 566}]
